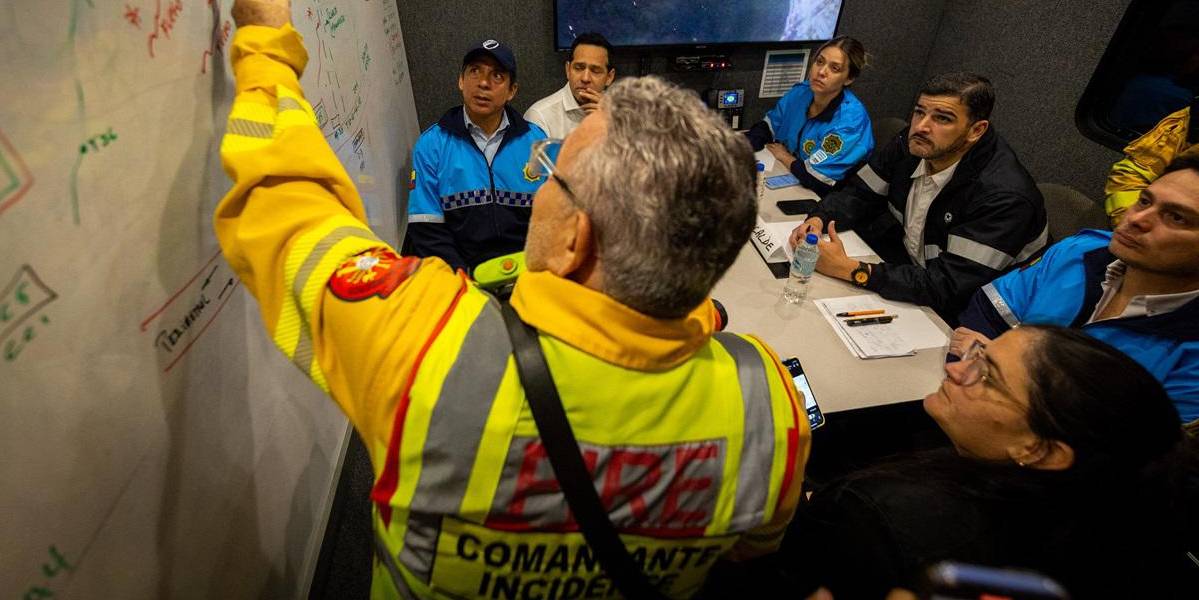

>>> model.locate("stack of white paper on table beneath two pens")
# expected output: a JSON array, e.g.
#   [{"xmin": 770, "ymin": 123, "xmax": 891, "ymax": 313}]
[{"xmin": 814, "ymin": 295, "xmax": 948, "ymax": 359}]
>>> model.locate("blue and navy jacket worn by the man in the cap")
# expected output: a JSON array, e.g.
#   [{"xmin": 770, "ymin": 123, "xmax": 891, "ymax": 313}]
[{"xmin": 408, "ymin": 106, "xmax": 546, "ymax": 270}]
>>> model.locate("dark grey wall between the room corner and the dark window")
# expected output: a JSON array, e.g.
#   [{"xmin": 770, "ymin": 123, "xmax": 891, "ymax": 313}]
[{"xmin": 924, "ymin": 0, "xmax": 1128, "ymax": 202}]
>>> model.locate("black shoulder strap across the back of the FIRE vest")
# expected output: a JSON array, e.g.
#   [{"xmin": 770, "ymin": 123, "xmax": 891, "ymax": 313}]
[{"xmin": 501, "ymin": 302, "xmax": 665, "ymax": 599}]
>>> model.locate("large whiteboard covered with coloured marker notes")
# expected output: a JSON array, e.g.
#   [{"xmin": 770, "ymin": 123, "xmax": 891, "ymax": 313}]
[{"xmin": 0, "ymin": 0, "xmax": 418, "ymax": 599}]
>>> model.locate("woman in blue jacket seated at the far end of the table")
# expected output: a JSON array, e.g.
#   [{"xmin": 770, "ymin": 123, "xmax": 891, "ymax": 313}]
[{"xmin": 747, "ymin": 36, "xmax": 874, "ymax": 196}]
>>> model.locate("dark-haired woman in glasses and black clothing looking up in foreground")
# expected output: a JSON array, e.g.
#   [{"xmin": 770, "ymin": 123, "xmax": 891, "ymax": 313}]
[{"xmin": 781, "ymin": 325, "xmax": 1199, "ymax": 599}]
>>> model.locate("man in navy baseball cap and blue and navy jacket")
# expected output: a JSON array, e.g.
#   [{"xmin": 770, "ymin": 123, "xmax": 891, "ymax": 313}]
[{"xmin": 408, "ymin": 40, "xmax": 546, "ymax": 271}]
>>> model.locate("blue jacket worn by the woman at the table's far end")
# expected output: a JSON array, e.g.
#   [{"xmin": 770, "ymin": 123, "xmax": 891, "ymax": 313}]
[{"xmin": 748, "ymin": 82, "xmax": 874, "ymax": 194}]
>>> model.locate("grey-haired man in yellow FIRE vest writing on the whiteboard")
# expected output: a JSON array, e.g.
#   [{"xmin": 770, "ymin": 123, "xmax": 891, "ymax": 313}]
[{"xmin": 215, "ymin": 0, "xmax": 809, "ymax": 599}]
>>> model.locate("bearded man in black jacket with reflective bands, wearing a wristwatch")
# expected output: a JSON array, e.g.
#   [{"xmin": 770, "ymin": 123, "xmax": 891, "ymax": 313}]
[{"xmin": 791, "ymin": 73, "xmax": 1049, "ymax": 322}]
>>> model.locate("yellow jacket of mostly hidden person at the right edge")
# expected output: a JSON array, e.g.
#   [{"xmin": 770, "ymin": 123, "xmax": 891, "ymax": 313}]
[{"xmin": 1103, "ymin": 98, "xmax": 1199, "ymax": 227}]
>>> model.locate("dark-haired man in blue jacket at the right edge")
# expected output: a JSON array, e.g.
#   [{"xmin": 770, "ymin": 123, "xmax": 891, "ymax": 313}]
[{"xmin": 950, "ymin": 155, "xmax": 1199, "ymax": 425}]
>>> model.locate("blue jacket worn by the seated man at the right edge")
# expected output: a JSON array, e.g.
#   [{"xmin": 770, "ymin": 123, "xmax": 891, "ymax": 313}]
[{"xmin": 962, "ymin": 229, "xmax": 1199, "ymax": 422}]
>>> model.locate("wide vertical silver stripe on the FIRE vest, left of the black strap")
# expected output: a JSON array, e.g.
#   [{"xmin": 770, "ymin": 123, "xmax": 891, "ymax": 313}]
[{"xmin": 399, "ymin": 302, "xmax": 503, "ymax": 583}]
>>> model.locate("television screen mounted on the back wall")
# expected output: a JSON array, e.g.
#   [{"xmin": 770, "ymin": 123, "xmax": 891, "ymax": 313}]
[{"xmin": 554, "ymin": 0, "xmax": 842, "ymax": 50}]
